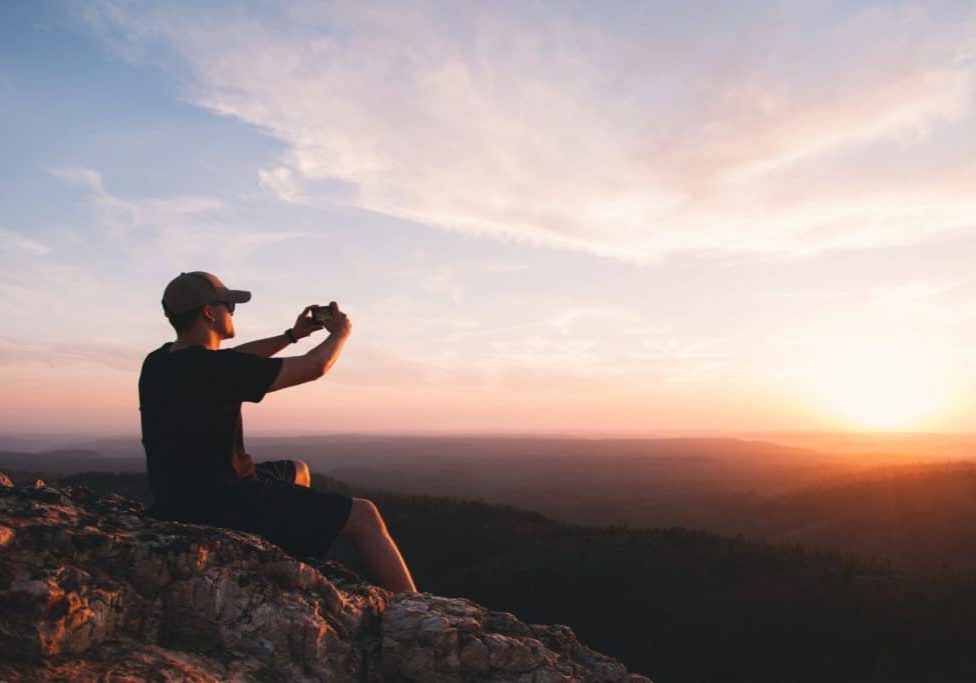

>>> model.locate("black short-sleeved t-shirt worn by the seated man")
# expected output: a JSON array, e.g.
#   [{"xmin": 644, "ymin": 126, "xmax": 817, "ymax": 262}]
[{"xmin": 139, "ymin": 342, "xmax": 283, "ymax": 509}]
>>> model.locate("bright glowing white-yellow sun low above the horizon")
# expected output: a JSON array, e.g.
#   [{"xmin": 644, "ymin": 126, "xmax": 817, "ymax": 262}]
[{"xmin": 817, "ymin": 340, "xmax": 944, "ymax": 431}]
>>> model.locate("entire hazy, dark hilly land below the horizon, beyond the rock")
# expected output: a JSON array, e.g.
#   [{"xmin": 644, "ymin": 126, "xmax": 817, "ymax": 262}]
[{"xmin": 0, "ymin": 436, "xmax": 976, "ymax": 681}]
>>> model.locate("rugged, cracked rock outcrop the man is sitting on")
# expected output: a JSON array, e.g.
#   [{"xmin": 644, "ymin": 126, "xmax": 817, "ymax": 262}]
[{"xmin": 0, "ymin": 474, "xmax": 649, "ymax": 683}]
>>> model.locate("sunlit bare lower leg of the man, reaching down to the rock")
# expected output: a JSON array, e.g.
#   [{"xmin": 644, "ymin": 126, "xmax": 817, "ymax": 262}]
[{"xmin": 340, "ymin": 498, "xmax": 417, "ymax": 593}]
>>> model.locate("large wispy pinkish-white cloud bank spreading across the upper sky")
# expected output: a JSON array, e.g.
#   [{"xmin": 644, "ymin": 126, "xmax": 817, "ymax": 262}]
[{"xmin": 89, "ymin": 1, "xmax": 976, "ymax": 262}]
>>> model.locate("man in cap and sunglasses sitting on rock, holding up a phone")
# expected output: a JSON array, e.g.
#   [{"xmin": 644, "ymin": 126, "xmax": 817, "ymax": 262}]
[{"xmin": 139, "ymin": 271, "xmax": 416, "ymax": 593}]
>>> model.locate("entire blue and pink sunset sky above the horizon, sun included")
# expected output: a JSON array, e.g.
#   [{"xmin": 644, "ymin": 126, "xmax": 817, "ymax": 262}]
[{"xmin": 0, "ymin": 0, "xmax": 976, "ymax": 435}]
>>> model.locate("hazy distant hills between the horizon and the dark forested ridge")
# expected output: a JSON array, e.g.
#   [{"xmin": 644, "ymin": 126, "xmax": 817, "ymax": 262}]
[{"xmin": 0, "ymin": 435, "xmax": 976, "ymax": 572}]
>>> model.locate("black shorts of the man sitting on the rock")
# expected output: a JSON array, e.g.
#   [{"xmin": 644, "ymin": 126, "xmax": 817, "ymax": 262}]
[{"xmin": 156, "ymin": 460, "xmax": 352, "ymax": 557}]
